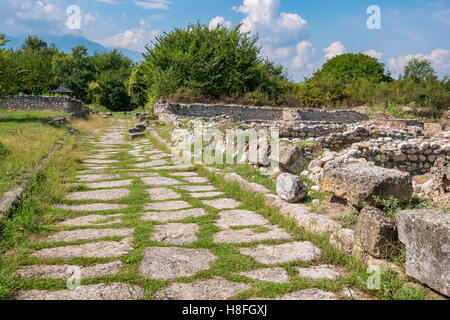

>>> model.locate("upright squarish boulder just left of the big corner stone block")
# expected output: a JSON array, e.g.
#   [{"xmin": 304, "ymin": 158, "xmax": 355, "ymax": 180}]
[{"xmin": 353, "ymin": 207, "xmax": 398, "ymax": 258}]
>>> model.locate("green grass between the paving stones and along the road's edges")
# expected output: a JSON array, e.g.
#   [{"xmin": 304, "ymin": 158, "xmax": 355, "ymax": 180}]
[{"xmin": 0, "ymin": 117, "xmax": 426, "ymax": 299}]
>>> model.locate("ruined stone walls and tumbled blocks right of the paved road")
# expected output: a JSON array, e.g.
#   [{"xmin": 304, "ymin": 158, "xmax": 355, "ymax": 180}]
[{"xmin": 154, "ymin": 101, "xmax": 450, "ymax": 296}]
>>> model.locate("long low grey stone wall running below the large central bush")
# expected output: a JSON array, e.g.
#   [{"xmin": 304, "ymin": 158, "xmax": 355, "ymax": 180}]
[{"xmin": 154, "ymin": 103, "xmax": 368, "ymax": 124}]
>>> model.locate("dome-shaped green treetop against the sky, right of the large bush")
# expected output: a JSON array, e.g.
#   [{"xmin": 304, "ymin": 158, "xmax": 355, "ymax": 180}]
[{"xmin": 313, "ymin": 53, "xmax": 392, "ymax": 83}]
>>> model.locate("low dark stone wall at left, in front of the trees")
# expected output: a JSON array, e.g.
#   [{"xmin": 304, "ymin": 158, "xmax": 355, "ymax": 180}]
[{"xmin": 0, "ymin": 96, "xmax": 89, "ymax": 117}]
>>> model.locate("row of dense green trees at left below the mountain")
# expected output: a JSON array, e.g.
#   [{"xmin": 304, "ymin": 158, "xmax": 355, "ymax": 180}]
[{"xmin": 0, "ymin": 36, "xmax": 135, "ymax": 111}]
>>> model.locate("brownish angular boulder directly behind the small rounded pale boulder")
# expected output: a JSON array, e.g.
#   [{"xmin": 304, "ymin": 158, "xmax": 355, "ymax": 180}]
[{"xmin": 269, "ymin": 140, "xmax": 312, "ymax": 172}]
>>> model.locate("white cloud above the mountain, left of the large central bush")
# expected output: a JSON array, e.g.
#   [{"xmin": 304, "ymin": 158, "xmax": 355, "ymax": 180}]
[{"xmin": 100, "ymin": 24, "xmax": 158, "ymax": 52}]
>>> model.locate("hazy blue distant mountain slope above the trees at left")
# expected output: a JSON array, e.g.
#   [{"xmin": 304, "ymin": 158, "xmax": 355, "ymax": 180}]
[{"xmin": 6, "ymin": 35, "xmax": 143, "ymax": 62}]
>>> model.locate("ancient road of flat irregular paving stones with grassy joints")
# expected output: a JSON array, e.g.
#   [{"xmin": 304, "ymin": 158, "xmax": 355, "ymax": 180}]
[{"xmin": 15, "ymin": 124, "xmax": 360, "ymax": 300}]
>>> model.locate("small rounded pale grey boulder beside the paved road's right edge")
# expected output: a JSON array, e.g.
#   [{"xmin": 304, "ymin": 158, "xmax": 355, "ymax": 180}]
[{"xmin": 277, "ymin": 173, "xmax": 308, "ymax": 203}]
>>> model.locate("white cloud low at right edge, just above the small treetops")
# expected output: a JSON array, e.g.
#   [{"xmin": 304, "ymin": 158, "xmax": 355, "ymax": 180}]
[{"xmin": 388, "ymin": 48, "xmax": 450, "ymax": 74}]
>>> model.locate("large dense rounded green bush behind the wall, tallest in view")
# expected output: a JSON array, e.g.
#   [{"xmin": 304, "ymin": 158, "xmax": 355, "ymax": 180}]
[{"xmin": 142, "ymin": 24, "xmax": 294, "ymax": 105}]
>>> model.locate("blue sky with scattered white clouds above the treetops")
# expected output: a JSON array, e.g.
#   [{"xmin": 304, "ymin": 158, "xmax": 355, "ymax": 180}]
[{"xmin": 0, "ymin": 0, "xmax": 450, "ymax": 80}]
